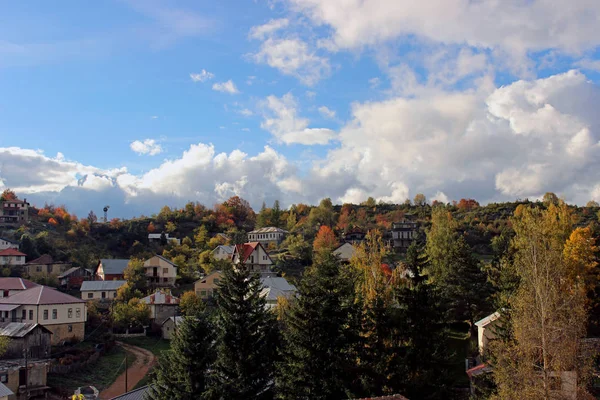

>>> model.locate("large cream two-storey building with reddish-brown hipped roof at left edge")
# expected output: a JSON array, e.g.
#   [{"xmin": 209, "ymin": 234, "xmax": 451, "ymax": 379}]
[{"xmin": 0, "ymin": 286, "xmax": 87, "ymax": 344}]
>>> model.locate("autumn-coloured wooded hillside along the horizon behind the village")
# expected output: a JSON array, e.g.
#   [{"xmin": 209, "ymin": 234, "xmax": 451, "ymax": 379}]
[{"xmin": 0, "ymin": 189, "xmax": 600, "ymax": 272}]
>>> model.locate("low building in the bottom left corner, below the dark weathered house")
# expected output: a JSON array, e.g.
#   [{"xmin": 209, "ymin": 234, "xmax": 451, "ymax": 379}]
[{"xmin": 0, "ymin": 358, "xmax": 50, "ymax": 400}]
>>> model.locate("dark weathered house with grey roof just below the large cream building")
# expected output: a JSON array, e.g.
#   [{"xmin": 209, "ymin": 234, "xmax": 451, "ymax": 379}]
[{"xmin": 0, "ymin": 322, "xmax": 52, "ymax": 359}]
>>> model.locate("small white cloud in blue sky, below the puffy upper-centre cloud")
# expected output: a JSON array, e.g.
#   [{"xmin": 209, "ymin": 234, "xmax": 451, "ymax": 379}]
[{"xmin": 260, "ymin": 93, "xmax": 336, "ymax": 145}]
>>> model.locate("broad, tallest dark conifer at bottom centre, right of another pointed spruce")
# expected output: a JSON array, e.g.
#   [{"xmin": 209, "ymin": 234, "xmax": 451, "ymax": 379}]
[{"xmin": 277, "ymin": 253, "xmax": 358, "ymax": 400}]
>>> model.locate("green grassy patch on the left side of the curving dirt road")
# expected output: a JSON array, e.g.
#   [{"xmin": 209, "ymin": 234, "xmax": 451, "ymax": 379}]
[{"xmin": 48, "ymin": 346, "xmax": 136, "ymax": 394}]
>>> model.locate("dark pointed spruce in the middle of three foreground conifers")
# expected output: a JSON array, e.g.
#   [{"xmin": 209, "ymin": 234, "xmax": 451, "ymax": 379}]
[{"xmin": 209, "ymin": 267, "xmax": 277, "ymax": 400}]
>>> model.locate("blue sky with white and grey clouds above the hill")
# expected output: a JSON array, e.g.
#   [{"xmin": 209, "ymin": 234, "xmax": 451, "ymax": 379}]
[{"xmin": 0, "ymin": 0, "xmax": 600, "ymax": 218}]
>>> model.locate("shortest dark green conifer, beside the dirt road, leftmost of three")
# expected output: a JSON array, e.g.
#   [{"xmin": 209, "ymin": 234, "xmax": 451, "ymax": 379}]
[{"xmin": 147, "ymin": 314, "xmax": 214, "ymax": 400}]
